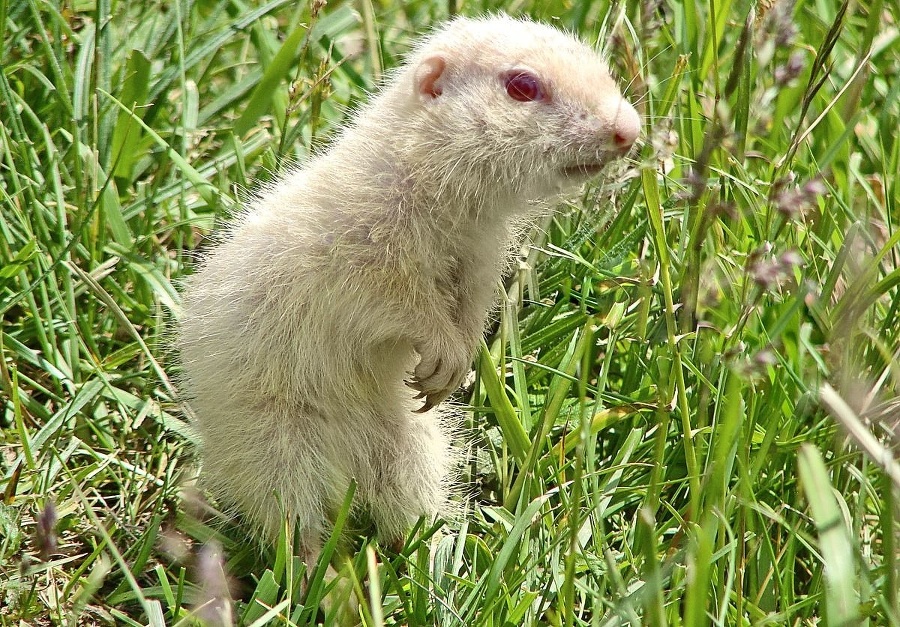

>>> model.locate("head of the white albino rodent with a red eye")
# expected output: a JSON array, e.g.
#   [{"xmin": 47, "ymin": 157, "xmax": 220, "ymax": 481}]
[{"xmin": 400, "ymin": 15, "xmax": 641, "ymax": 204}]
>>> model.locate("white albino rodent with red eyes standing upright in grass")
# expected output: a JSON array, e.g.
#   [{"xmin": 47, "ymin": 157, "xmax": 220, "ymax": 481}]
[{"xmin": 179, "ymin": 15, "xmax": 640, "ymax": 558}]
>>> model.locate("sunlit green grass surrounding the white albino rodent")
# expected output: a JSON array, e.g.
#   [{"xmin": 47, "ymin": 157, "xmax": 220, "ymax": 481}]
[{"xmin": 0, "ymin": 0, "xmax": 900, "ymax": 627}]
